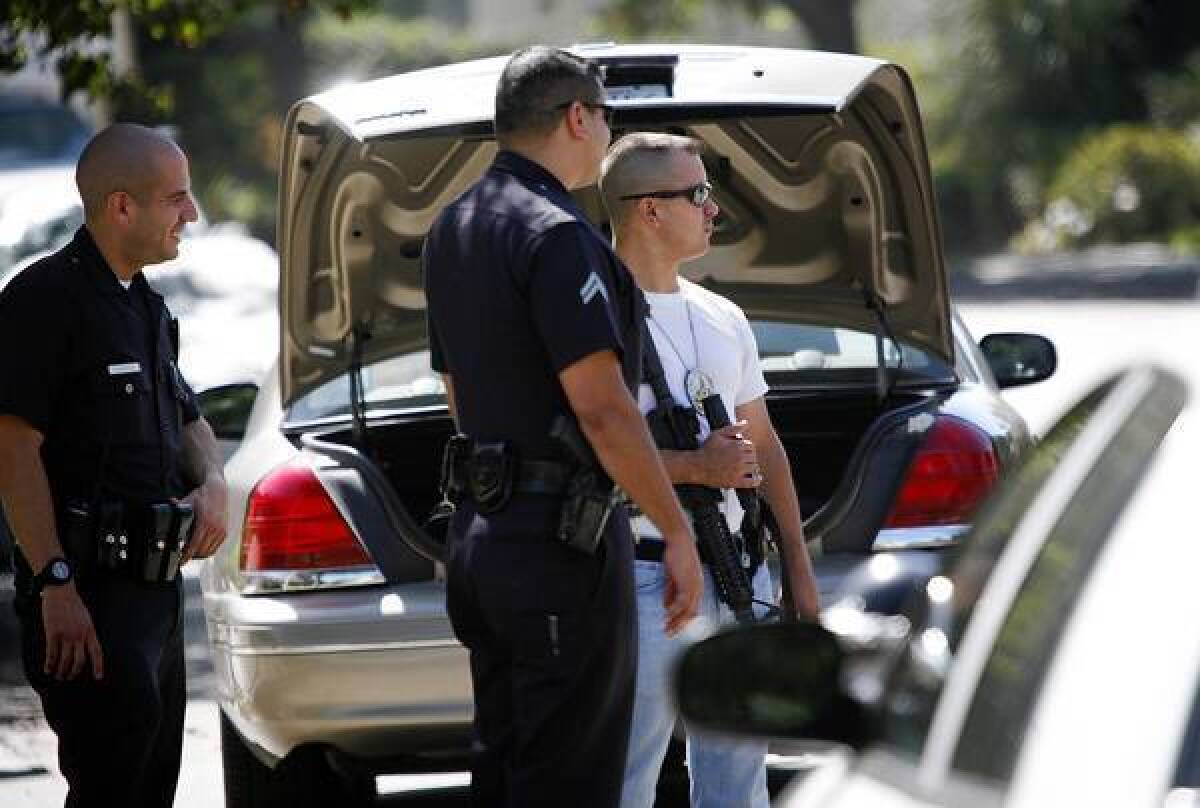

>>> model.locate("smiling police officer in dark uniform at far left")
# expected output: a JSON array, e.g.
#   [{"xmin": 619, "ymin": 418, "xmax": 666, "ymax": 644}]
[{"xmin": 0, "ymin": 124, "xmax": 227, "ymax": 807}]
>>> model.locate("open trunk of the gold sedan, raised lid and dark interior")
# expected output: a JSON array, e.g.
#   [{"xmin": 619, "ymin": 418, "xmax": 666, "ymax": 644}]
[{"xmin": 278, "ymin": 46, "xmax": 956, "ymax": 581}]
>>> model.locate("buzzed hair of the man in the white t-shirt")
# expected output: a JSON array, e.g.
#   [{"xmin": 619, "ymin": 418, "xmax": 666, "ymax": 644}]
[{"xmin": 600, "ymin": 132, "xmax": 704, "ymax": 225}]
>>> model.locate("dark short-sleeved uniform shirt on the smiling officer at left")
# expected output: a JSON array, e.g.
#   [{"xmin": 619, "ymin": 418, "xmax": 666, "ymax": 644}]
[{"xmin": 0, "ymin": 228, "xmax": 198, "ymax": 504}]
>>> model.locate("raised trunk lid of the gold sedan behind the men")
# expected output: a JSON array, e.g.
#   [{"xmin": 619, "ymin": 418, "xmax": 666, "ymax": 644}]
[{"xmin": 277, "ymin": 46, "xmax": 953, "ymax": 406}]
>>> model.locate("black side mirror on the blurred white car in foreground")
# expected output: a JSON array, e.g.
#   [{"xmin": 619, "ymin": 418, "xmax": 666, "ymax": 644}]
[{"xmin": 674, "ymin": 623, "xmax": 864, "ymax": 747}]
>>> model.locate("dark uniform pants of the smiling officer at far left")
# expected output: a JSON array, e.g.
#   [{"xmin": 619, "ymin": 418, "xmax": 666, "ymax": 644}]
[{"xmin": 17, "ymin": 576, "xmax": 187, "ymax": 808}]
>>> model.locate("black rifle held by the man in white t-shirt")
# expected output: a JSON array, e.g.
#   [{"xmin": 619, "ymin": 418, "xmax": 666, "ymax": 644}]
[{"xmin": 642, "ymin": 319, "xmax": 755, "ymax": 623}]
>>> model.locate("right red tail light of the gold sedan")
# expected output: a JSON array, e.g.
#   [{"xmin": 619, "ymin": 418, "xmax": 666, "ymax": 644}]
[{"xmin": 884, "ymin": 415, "xmax": 1000, "ymax": 527}]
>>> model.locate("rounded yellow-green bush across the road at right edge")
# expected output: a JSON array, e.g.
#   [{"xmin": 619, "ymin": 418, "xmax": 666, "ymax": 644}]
[{"xmin": 1018, "ymin": 124, "xmax": 1200, "ymax": 250}]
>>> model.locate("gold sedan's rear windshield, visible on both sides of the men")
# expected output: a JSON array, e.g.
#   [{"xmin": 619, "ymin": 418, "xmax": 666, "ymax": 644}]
[{"xmin": 288, "ymin": 321, "xmax": 954, "ymax": 423}]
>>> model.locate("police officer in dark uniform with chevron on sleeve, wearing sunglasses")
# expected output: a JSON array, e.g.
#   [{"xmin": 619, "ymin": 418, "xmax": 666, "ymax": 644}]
[{"xmin": 425, "ymin": 46, "xmax": 701, "ymax": 808}]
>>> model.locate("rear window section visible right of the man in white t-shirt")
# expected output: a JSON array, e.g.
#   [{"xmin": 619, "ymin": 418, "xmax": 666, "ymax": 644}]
[{"xmin": 750, "ymin": 319, "xmax": 953, "ymax": 383}]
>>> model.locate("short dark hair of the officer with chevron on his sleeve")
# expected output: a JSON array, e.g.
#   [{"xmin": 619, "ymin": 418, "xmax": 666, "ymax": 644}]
[{"xmin": 496, "ymin": 44, "xmax": 604, "ymax": 142}]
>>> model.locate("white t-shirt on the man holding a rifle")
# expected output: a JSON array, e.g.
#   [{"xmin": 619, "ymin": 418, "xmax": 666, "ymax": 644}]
[{"xmin": 634, "ymin": 279, "xmax": 768, "ymax": 537}]
